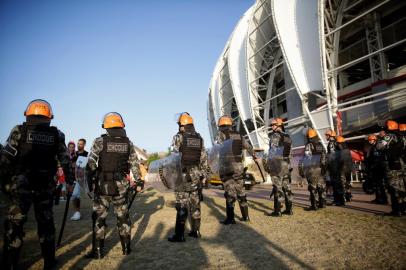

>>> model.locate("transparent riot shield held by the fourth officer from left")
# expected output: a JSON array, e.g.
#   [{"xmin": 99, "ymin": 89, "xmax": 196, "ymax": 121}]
[{"xmin": 219, "ymin": 139, "xmax": 244, "ymax": 177}]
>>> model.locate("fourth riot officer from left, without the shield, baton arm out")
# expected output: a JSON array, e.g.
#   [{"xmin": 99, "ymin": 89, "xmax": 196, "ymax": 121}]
[{"xmin": 216, "ymin": 116, "xmax": 255, "ymax": 225}]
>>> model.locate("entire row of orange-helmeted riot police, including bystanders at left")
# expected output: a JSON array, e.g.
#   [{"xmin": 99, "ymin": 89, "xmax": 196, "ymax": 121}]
[{"xmin": 0, "ymin": 100, "xmax": 406, "ymax": 269}]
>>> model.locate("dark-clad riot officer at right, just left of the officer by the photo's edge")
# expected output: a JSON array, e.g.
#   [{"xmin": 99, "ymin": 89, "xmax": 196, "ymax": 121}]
[{"xmin": 366, "ymin": 134, "xmax": 388, "ymax": 204}]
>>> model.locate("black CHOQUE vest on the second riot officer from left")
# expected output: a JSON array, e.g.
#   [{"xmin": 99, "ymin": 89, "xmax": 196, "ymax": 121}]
[{"xmin": 98, "ymin": 135, "xmax": 130, "ymax": 195}]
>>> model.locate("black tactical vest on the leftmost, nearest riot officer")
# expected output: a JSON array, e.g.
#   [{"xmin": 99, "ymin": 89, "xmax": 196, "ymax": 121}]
[{"xmin": 17, "ymin": 123, "xmax": 59, "ymax": 185}]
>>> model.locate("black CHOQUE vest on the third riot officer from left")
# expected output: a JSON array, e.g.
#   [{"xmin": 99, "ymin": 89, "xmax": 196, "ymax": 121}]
[{"xmin": 179, "ymin": 132, "xmax": 203, "ymax": 167}]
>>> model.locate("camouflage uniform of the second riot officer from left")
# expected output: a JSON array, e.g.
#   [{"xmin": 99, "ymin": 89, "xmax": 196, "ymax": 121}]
[{"xmin": 87, "ymin": 129, "xmax": 140, "ymax": 257}]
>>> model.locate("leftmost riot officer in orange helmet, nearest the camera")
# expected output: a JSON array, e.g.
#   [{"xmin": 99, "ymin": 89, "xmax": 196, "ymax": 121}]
[{"xmin": 0, "ymin": 99, "xmax": 69, "ymax": 269}]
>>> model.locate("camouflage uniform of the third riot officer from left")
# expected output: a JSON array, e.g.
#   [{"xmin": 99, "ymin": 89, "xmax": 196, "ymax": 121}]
[{"xmin": 171, "ymin": 132, "xmax": 208, "ymax": 237}]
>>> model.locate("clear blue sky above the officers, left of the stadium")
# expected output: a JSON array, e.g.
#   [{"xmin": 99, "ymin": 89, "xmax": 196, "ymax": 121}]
[{"xmin": 0, "ymin": 0, "xmax": 254, "ymax": 152}]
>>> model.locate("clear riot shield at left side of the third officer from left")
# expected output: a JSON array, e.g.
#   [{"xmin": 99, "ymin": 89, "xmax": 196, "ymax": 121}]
[{"xmin": 146, "ymin": 153, "xmax": 183, "ymax": 191}]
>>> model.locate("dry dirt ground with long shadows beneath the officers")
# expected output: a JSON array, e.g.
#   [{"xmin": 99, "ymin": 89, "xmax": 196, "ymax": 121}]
[{"xmin": 1, "ymin": 188, "xmax": 406, "ymax": 269}]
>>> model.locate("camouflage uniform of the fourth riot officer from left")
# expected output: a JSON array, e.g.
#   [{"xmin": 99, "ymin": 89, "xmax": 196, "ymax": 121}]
[{"xmin": 216, "ymin": 127, "xmax": 255, "ymax": 224}]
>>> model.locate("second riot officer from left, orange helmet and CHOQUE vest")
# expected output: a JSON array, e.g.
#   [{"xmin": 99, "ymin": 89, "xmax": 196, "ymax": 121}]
[{"xmin": 86, "ymin": 112, "xmax": 143, "ymax": 259}]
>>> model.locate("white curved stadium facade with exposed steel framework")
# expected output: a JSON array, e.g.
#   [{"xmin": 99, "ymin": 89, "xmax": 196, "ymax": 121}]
[{"xmin": 207, "ymin": 0, "xmax": 406, "ymax": 153}]
